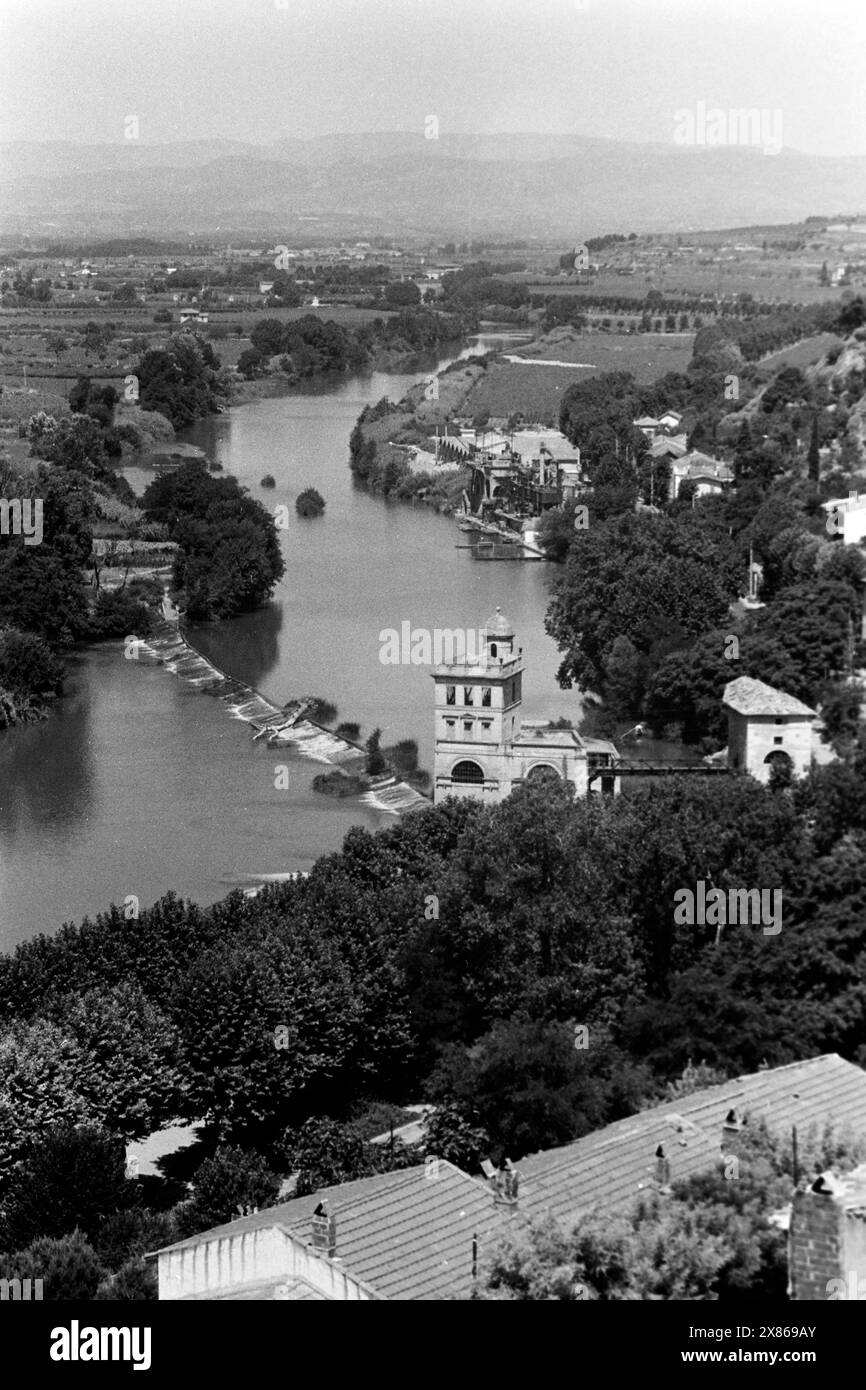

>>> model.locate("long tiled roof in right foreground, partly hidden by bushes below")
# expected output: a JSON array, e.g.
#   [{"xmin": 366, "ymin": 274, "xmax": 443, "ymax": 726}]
[{"xmin": 518, "ymin": 1054, "xmax": 866, "ymax": 1223}]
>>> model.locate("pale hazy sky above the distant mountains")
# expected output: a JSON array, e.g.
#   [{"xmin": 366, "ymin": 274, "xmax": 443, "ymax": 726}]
[{"xmin": 0, "ymin": 0, "xmax": 866, "ymax": 154}]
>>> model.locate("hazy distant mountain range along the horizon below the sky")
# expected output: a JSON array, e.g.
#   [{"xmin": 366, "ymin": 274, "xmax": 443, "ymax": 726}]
[{"xmin": 0, "ymin": 133, "xmax": 866, "ymax": 243}]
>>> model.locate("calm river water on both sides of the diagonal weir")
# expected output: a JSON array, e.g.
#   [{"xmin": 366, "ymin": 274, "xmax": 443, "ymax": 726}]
[{"xmin": 0, "ymin": 330, "xmax": 580, "ymax": 949}]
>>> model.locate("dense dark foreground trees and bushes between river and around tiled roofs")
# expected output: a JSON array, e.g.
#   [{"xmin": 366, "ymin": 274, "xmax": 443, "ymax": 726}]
[{"xmin": 0, "ymin": 767, "xmax": 866, "ymax": 1298}]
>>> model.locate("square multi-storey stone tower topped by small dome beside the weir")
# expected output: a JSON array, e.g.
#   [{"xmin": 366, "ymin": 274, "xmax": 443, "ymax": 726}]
[{"xmin": 432, "ymin": 609, "xmax": 524, "ymax": 802}]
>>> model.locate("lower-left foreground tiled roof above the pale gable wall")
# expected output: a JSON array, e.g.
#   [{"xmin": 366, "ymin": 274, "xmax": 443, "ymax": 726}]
[{"xmin": 156, "ymin": 1159, "xmax": 507, "ymax": 1300}]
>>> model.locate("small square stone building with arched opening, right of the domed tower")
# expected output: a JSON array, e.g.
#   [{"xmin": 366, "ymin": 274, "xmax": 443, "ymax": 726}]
[{"xmin": 724, "ymin": 676, "xmax": 817, "ymax": 783}]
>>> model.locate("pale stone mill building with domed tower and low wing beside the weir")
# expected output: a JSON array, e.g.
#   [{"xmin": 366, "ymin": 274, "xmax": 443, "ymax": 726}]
[{"xmin": 432, "ymin": 609, "xmax": 620, "ymax": 803}]
